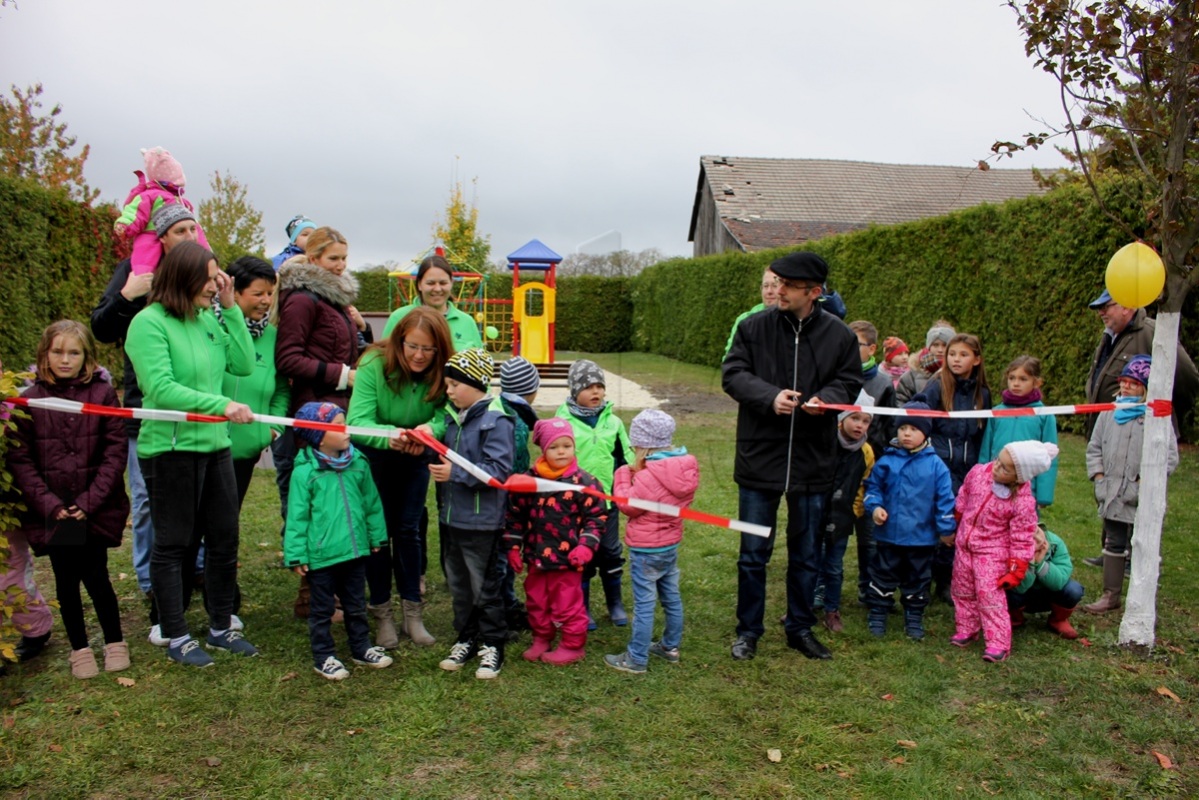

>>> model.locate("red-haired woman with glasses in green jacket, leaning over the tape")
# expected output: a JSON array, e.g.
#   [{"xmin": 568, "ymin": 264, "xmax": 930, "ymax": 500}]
[{"xmin": 345, "ymin": 306, "xmax": 454, "ymax": 649}]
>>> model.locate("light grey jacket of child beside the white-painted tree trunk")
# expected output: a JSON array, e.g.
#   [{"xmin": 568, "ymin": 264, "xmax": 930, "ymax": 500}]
[{"xmin": 1086, "ymin": 411, "xmax": 1179, "ymax": 523}]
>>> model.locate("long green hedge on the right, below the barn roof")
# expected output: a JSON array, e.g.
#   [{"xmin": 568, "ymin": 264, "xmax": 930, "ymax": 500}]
[{"xmin": 632, "ymin": 178, "xmax": 1199, "ymax": 428}]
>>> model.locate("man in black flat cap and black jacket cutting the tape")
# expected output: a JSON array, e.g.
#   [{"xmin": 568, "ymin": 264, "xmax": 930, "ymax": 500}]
[{"xmin": 722, "ymin": 252, "xmax": 862, "ymax": 661}]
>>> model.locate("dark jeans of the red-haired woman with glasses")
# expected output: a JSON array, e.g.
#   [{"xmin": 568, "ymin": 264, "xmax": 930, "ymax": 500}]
[{"xmin": 362, "ymin": 447, "xmax": 429, "ymax": 606}]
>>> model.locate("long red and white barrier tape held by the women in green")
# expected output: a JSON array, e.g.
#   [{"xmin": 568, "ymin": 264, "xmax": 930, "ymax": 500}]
[{"xmin": 4, "ymin": 397, "xmax": 771, "ymax": 537}]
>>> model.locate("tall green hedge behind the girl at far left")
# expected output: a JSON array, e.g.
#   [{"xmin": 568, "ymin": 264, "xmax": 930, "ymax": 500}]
[{"xmin": 0, "ymin": 175, "xmax": 127, "ymax": 368}]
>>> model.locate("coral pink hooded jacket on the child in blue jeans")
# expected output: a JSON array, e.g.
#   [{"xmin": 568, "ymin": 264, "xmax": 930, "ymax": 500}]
[{"xmin": 613, "ymin": 450, "xmax": 699, "ymax": 549}]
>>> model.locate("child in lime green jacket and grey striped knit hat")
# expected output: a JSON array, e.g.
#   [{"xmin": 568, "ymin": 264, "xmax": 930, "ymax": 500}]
[{"xmin": 554, "ymin": 359, "xmax": 633, "ymax": 631}]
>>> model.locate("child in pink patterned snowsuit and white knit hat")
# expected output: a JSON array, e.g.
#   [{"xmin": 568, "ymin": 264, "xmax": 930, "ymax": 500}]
[{"xmin": 950, "ymin": 439, "xmax": 1058, "ymax": 661}]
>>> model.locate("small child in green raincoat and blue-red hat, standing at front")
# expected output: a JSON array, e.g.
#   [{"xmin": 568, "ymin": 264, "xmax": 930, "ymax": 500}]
[{"xmin": 283, "ymin": 403, "xmax": 392, "ymax": 680}]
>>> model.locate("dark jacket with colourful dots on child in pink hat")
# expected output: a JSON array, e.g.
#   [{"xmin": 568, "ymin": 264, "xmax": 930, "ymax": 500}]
[{"xmin": 504, "ymin": 462, "xmax": 608, "ymax": 570}]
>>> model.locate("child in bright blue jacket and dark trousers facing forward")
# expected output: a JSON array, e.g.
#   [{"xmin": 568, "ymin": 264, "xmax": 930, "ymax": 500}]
[{"xmin": 864, "ymin": 402, "xmax": 957, "ymax": 639}]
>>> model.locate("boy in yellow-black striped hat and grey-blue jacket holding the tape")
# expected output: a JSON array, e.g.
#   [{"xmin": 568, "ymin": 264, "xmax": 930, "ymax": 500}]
[{"xmin": 429, "ymin": 349, "xmax": 516, "ymax": 680}]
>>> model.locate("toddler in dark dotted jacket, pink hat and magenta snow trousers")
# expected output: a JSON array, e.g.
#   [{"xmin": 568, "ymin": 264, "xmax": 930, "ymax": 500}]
[{"xmin": 504, "ymin": 417, "xmax": 608, "ymax": 666}]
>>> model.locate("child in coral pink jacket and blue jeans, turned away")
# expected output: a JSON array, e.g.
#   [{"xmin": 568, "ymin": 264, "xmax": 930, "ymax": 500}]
[{"xmin": 603, "ymin": 409, "xmax": 699, "ymax": 675}]
